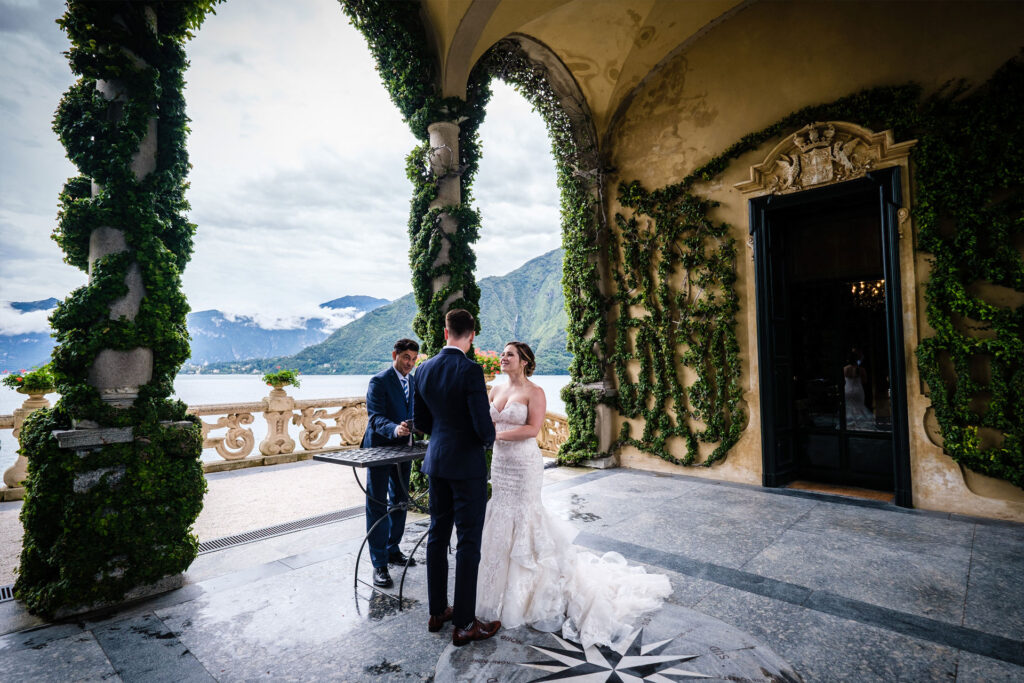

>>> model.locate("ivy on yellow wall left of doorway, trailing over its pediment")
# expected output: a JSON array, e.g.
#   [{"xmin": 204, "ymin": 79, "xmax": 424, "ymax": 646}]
[{"xmin": 608, "ymin": 85, "xmax": 920, "ymax": 467}]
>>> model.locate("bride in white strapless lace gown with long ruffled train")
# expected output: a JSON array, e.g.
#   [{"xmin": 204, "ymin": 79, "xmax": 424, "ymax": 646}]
[{"xmin": 476, "ymin": 342, "xmax": 672, "ymax": 647}]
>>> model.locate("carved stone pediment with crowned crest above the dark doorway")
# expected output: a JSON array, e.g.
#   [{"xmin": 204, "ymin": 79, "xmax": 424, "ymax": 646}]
[{"xmin": 735, "ymin": 121, "xmax": 916, "ymax": 195}]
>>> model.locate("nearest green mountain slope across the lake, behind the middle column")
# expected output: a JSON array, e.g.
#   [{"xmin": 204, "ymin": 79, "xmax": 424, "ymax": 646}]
[{"xmin": 203, "ymin": 249, "xmax": 571, "ymax": 375}]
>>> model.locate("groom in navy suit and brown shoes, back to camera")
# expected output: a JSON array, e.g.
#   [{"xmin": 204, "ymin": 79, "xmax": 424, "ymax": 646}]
[{"xmin": 416, "ymin": 308, "xmax": 501, "ymax": 646}]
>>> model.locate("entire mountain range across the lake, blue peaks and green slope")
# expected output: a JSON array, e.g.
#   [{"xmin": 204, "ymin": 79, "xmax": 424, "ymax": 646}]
[{"xmin": 0, "ymin": 249, "xmax": 571, "ymax": 375}]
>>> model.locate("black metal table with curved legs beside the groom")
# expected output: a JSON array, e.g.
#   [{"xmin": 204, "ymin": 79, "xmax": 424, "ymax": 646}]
[{"xmin": 313, "ymin": 441, "xmax": 427, "ymax": 611}]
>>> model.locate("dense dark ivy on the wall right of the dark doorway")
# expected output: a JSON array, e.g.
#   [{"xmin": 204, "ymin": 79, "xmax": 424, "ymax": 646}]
[{"xmin": 913, "ymin": 59, "xmax": 1024, "ymax": 487}]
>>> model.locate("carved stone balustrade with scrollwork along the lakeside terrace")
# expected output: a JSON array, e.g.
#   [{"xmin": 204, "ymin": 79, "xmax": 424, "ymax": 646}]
[{"xmin": 0, "ymin": 388, "xmax": 568, "ymax": 501}]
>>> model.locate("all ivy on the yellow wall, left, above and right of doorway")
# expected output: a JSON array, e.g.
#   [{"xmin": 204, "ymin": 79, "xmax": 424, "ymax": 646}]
[{"xmin": 609, "ymin": 59, "xmax": 1024, "ymax": 485}]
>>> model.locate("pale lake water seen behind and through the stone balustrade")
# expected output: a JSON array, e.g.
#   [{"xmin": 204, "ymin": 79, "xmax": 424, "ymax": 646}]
[{"xmin": 0, "ymin": 375, "xmax": 569, "ymax": 473}]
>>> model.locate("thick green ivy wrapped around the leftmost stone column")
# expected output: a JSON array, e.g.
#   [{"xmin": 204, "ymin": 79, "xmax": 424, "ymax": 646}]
[{"xmin": 14, "ymin": 0, "xmax": 215, "ymax": 614}]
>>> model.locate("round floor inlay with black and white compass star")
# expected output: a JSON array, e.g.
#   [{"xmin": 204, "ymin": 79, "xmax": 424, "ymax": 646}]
[{"xmin": 434, "ymin": 604, "xmax": 801, "ymax": 683}]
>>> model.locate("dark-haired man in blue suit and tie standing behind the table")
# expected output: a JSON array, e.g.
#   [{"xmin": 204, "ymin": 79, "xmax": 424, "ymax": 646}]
[{"xmin": 361, "ymin": 339, "xmax": 420, "ymax": 588}]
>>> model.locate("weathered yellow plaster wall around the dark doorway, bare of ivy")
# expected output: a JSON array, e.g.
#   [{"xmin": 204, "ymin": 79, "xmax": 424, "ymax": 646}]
[{"xmin": 607, "ymin": 2, "xmax": 1024, "ymax": 520}]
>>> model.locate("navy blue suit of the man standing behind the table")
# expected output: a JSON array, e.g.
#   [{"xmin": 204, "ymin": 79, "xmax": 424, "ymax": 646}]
[{"xmin": 362, "ymin": 367, "xmax": 416, "ymax": 567}]
